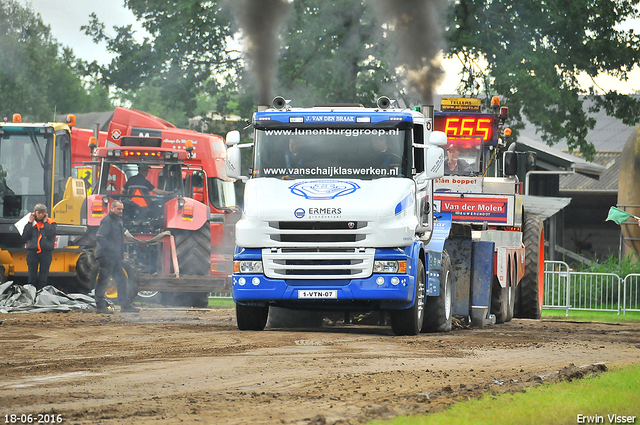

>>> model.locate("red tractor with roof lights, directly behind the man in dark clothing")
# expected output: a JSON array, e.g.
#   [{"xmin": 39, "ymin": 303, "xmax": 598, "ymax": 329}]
[{"xmin": 86, "ymin": 137, "xmax": 218, "ymax": 306}]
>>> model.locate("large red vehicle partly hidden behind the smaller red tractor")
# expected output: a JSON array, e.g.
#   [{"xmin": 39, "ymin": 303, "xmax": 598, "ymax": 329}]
[{"xmin": 71, "ymin": 108, "xmax": 240, "ymax": 304}]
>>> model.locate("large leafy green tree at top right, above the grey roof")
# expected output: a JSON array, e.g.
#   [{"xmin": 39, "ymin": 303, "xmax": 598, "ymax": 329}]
[{"xmin": 447, "ymin": 0, "xmax": 640, "ymax": 158}]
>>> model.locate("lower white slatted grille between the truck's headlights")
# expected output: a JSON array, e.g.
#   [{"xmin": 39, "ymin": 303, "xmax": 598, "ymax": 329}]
[{"xmin": 262, "ymin": 248, "xmax": 375, "ymax": 279}]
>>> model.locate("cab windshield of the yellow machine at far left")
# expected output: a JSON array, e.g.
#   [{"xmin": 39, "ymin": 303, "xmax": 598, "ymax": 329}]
[{"xmin": 0, "ymin": 131, "xmax": 52, "ymax": 217}]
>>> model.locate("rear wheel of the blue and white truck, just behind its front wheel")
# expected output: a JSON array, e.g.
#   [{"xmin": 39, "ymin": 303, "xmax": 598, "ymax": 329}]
[{"xmin": 422, "ymin": 251, "xmax": 453, "ymax": 332}]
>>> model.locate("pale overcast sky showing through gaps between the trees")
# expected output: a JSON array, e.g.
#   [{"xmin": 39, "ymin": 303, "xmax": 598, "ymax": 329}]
[{"xmin": 20, "ymin": 0, "xmax": 640, "ymax": 94}]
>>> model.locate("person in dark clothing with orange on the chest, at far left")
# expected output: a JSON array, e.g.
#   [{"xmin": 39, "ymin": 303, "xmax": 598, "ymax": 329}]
[{"xmin": 22, "ymin": 204, "xmax": 56, "ymax": 289}]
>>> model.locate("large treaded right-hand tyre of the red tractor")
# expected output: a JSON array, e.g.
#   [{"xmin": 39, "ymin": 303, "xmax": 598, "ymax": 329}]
[{"xmin": 160, "ymin": 222, "xmax": 211, "ymax": 308}]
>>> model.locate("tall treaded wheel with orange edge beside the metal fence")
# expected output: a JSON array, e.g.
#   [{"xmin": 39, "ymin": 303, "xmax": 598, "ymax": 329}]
[{"xmin": 517, "ymin": 215, "xmax": 544, "ymax": 319}]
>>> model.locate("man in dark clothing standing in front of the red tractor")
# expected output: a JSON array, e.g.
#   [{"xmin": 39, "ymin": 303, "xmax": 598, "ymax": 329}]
[{"xmin": 95, "ymin": 201, "xmax": 140, "ymax": 314}]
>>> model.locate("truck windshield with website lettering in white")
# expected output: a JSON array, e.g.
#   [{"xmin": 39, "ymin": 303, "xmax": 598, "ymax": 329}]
[{"xmin": 253, "ymin": 128, "xmax": 411, "ymax": 180}]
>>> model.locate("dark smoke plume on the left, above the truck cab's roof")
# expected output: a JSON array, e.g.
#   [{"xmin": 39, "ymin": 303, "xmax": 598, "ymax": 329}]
[{"xmin": 232, "ymin": 0, "xmax": 289, "ymax": 105}]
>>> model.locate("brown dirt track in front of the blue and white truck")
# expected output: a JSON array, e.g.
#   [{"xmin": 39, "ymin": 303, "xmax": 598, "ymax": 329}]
[{"xmin": 0, "ymin": 308, "xmax": 640, "ymax": 424}]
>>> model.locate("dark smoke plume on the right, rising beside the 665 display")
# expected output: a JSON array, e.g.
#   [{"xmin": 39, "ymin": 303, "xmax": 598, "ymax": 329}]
[{"xmin": 373, "ymin": 0, "xmax": 444, "ymax": 104}]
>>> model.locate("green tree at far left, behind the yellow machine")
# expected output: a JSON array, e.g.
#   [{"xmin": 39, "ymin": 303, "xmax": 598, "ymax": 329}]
[{"xmin": 0, "ymin": 0, "xmax": 111, "ymax": 121}]
